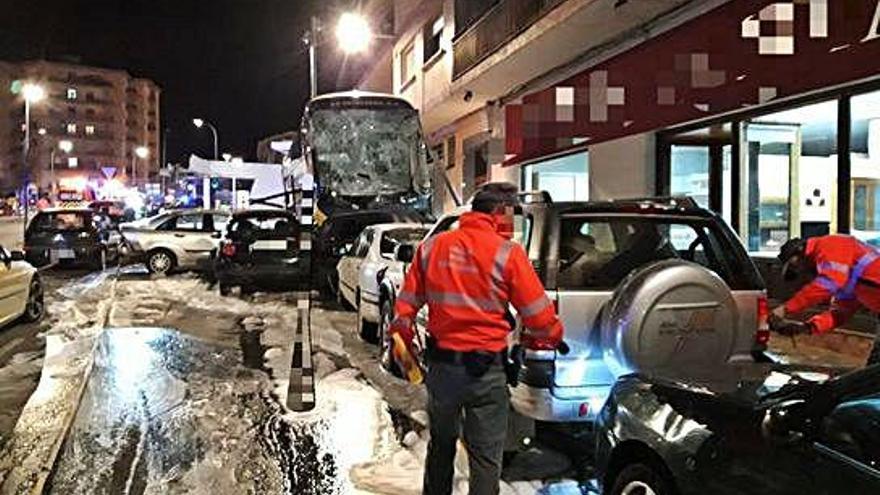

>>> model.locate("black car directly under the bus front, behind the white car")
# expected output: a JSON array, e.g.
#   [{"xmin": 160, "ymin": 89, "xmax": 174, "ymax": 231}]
[{"xmin": 312, "ymin": 210, "xmax": 426, "ymax": 293}]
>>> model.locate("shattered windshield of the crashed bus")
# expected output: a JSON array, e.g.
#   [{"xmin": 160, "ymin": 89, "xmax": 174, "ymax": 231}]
[{"xmin": 311, "ymin": 108, "xmax": 430, "ymax": 196}]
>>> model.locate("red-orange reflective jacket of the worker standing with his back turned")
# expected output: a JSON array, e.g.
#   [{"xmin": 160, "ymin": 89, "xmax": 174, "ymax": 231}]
[{"xmin": 394, "ymin": 212, "xmax": 562, "ymax": 352}]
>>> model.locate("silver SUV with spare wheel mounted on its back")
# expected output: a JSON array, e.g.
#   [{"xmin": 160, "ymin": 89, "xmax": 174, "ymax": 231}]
[{"xmin": 382, "ymin": 195, "xmax": 769, "ymax": 422}]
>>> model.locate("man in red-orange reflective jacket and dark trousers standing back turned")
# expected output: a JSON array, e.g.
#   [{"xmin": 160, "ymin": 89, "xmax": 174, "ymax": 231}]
[{"xmin": 390, "ymin": 183, "xmax": 562, "ymax": 495}]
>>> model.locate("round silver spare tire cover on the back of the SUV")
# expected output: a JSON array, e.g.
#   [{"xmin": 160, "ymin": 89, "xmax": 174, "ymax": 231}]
[{"xmin": 601, "ymin": 259, "xmax": 739, "ymax": 376}]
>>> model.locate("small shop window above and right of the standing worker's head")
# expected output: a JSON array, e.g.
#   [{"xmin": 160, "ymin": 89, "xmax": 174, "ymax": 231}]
[{"xmin": 522, "ymin": 152, "xmax": 590, "ymax": 201}]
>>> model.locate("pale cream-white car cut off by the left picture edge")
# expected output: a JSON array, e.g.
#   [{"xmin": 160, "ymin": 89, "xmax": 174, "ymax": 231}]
[{"xmin": 0, "ymin": 246, "xmax": 46, "ymax": 327}]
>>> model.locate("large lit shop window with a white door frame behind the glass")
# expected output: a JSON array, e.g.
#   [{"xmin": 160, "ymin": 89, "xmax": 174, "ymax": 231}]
[{"xmin": 741, "ymin": 101, "xmax": 837, "ymax": 255}]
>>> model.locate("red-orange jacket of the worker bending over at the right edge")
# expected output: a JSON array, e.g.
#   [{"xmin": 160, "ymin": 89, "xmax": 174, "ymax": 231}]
[{"xmin": 785, "ymin": 235, "xmax": 880, "ymax": 333}]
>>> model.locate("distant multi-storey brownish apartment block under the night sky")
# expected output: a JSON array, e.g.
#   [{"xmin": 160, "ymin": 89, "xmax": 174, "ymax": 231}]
[{"xmin": 0, "ymin": 61, "xmax": 161, "ymax": 194}]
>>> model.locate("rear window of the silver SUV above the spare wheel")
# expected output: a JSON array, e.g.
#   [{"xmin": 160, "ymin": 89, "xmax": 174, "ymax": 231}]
[{"xmin": 557, "ymin": 216, "xmax": 761, "ymax": 290}]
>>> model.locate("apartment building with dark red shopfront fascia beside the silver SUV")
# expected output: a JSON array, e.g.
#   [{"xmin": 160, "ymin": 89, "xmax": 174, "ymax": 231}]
[{"xmin": 362, "ymin": 0, "xmax": 880, "ymax": 255}]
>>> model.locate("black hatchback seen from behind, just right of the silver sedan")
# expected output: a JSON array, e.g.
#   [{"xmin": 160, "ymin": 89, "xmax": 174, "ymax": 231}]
[{"xmin": 214, "ymin": 210, "xmax": 310, "ymax": 295}]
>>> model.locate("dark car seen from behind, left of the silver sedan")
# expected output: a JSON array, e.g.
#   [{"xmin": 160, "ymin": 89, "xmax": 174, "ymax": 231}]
[{"xmin": 24, "ymin": 208, "xmax": 119, "ymax": 268}]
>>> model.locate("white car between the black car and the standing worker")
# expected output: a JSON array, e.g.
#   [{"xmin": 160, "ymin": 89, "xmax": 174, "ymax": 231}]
[{"xmin": 336, "ymin": 223, "xmax": 430, "ymax": 341}]
